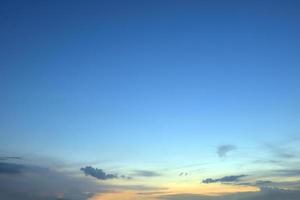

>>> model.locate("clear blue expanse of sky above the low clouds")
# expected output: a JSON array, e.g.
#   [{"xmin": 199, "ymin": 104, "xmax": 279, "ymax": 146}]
[{"xmin": 0, "ymin": 1, "xmax": 300, "ymax": 163}]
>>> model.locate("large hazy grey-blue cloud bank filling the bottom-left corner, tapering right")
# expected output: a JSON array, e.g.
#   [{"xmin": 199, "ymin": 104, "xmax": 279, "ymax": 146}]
[{"xmin": 0, "ymin": 163, "xmax": 109, "ymax": 200}]
